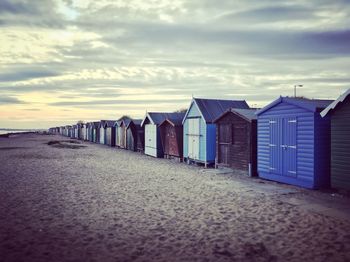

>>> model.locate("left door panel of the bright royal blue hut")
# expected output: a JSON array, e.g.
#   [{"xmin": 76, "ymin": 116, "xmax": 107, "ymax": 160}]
[{"xmin": 269, "ymin": 118, "xmax": 283, "ymax": 175}]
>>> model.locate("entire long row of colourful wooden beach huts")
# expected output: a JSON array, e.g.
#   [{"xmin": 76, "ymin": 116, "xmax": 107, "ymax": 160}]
[{"xmin": 49, "ymin": 89, "xmax": 350, "ymax": 190}]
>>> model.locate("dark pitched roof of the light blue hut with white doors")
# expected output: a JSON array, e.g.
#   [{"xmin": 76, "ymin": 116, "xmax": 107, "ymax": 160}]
[{"xmin": 182, "ymin": 98, "xmax": 249, "ymax": 123}]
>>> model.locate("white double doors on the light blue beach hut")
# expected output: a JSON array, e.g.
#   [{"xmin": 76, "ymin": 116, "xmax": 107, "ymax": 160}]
[{"xmin": 188, "ymin": 118, "xmax": 200, "ymax": 159}]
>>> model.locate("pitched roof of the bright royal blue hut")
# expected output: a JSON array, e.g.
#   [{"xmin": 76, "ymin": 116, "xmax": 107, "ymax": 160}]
[{"xmin": 256, "ymin": 96, "xmax": 333, "ymax": 115}]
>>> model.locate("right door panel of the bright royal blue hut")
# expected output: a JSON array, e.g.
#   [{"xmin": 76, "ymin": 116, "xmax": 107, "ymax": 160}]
[{"xmin": 282, "ymin": 118, "xmax": 297, "ymax": 177}]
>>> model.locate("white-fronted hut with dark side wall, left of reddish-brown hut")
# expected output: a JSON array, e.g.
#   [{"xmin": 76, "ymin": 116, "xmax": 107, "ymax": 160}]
[{"xmin": 141, "ymin": 112, "xmax": 179, "ymax": 157}]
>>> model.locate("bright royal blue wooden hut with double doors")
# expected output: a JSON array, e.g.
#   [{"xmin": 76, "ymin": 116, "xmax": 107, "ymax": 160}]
[{"xmin": 257, "ymin": 97, "xmax": 332, "ymax": 189}]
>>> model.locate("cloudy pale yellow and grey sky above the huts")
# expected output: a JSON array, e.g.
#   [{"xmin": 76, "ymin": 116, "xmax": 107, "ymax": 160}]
[{"xmin": 0, "ymin": 0, "xmax": 350, "ymax": 128}]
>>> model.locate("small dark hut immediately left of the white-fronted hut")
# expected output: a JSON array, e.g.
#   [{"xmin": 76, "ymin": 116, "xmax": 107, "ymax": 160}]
[{"xmin": 125, "ymin": 119, "xmax": 144, "ymax": 151}]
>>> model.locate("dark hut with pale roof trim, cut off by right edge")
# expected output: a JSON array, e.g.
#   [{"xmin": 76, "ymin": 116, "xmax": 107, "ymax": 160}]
[{"xmin": 321, "ymin": 89, "xmax": 350, "ymax": 190}]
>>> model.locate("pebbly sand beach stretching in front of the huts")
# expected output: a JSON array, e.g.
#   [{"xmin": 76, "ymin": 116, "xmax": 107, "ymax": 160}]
[{"xmin": 0, "ymin": 135, "xmax": 350, "ymax": 261}]
